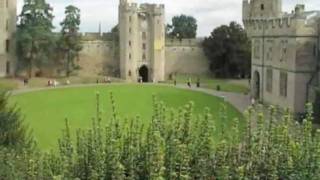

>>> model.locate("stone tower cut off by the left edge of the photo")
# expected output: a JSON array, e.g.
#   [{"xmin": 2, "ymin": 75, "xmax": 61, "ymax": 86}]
[{"xmin": 0, "ymin": 0, "xmax": 17, "ymax": 77}]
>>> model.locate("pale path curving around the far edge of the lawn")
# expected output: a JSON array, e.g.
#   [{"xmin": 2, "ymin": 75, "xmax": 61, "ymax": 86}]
[{"xmin": 11, "ymin": 83, "xmax": 250, "ymax": 112}]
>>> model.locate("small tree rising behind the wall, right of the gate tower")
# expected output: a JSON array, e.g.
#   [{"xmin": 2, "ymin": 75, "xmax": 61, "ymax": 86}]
[{"xmin": 166, "ymin": 14, "xmax": 198, "ymax": 39}]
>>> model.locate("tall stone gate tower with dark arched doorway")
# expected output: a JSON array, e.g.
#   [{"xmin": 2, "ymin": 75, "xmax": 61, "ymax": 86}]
[{"xmin": 119, "ymin": 0, "xmax": 165, "ymax": 82}]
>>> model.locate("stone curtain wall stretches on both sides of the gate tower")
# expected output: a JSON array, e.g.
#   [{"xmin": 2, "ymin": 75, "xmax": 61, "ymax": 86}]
[{"xmin": 79, "ymin": 33, "xmax": 209, "ymax": 77}]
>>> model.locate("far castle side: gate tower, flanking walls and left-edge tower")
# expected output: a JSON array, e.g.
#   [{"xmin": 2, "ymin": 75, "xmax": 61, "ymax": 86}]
[{"xmin": 0, "ymin": 0, "xmax": 209, "ymax": 82}]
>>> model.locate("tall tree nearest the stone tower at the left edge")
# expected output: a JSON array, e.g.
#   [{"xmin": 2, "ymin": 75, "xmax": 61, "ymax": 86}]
[{"xmin": 17, "ymin": 0, "xmax": 55, "ymax": 78}]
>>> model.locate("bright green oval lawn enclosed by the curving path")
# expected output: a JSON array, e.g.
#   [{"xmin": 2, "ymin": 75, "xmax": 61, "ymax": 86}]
[{"xmin": 11, "ymin": 85, "xmax": 242, "ymax": 150}]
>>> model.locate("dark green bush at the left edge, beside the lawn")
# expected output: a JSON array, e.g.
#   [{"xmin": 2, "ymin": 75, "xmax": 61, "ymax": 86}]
[{"xmin": 0, "ymin": 91, "xmax": 32, "ymax": 148}]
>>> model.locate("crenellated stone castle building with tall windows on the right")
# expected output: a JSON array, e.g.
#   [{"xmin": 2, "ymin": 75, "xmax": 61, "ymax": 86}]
[{"xmin": 243, "ymin": 0, "xmax": 320, "ymax": 113}]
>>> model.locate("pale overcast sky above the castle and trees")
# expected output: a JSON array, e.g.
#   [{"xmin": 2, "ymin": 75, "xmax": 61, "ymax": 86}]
[{"xmin": 17, "ymin": 0, "xmax": 320, "ymax": 36}]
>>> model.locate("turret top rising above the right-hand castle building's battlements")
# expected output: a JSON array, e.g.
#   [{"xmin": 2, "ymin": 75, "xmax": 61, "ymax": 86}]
[{"xmin": 243, "ymin": 0, "xmax": 282, "ymax": 19}]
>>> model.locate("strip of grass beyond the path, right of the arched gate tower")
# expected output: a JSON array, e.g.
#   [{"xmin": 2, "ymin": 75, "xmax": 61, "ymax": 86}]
[{"xmin": 167, "ymin": 75, "xmax": 249, "ymax": 93}]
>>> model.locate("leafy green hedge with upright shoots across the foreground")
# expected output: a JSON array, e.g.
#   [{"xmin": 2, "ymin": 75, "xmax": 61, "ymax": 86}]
[{"xmin": 0, "ymin": 93, "xmax": 320, "ymax": 180}]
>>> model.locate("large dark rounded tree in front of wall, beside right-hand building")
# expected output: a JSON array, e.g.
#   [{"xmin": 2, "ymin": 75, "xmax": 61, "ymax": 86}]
[{"xmin": 203, "ymin": 22, "xmax": 251, "ymax": 78}]
